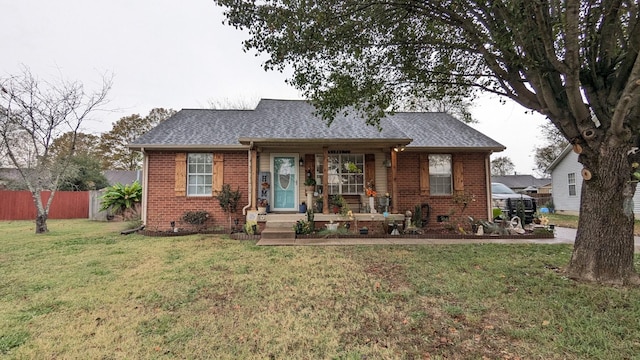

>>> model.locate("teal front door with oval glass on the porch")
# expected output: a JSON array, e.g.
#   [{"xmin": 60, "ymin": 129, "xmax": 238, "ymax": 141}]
[{"xmin": 271, "ymin": 154, "xmax": 298, "ymax": 211}]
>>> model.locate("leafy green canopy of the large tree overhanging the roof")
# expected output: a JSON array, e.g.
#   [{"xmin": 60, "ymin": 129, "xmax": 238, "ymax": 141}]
[{"xmin": 216, "ymin": 0, "xmax": 640, "ymax": 132}]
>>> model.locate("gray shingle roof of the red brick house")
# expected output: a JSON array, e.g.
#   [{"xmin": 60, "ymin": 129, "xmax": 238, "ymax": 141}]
[{"xmin": 129, "ymin": 99, "xmax": 504, "ymax": 151}]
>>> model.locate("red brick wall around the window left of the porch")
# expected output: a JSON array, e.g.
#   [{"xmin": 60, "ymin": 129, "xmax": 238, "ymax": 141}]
[{"xmin": 146, "ymin": 151, "xmax": 248, "ymax": 231}]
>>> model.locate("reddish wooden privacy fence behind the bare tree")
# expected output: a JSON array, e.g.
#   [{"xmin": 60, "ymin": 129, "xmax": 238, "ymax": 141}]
[{"xmin": 0, "ymin": 190, "xmax": 89, "ymax": 220}]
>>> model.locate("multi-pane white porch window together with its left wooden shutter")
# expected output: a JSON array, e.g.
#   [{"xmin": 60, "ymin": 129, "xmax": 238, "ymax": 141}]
[{"xmin": 316, "ymin": 154, "xmax": 365, "ymax": 195}]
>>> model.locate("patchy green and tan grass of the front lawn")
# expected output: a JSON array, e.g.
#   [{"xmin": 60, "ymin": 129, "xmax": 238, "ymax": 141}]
[{"xmin": 0, "ymin": 220, "xmax": 640, "ymax": 359}]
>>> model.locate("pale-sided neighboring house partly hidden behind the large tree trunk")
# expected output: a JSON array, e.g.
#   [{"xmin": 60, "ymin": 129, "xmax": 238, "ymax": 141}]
[{"xmin": 549, "ymin": 145, "xmax": 640, "ymax": 215}]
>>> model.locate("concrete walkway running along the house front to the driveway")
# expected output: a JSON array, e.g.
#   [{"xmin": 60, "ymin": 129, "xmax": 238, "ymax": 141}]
[{"xmin": 257, "ymin": 227, "xmax": 640, "ymax": 253}]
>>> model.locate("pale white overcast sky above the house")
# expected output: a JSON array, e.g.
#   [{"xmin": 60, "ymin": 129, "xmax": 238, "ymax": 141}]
[{"xmin": 0, "ymin": 0, "xmax": 546, "ymax": 174}]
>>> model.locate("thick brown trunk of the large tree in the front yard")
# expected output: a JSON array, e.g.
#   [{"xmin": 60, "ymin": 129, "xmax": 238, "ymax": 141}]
[{"xmin": 567, "ymin": 143, "xmax": 638, "ymax": 284}]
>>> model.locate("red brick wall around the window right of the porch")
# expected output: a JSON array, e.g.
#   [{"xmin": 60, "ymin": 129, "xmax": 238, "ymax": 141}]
[{"xmin": 388, "ymin": 152, "xmax": 488, "ymax": 225}]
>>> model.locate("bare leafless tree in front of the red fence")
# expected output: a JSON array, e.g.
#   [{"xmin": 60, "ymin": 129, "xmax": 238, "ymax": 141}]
[{"xmin": 0, "ymin": 68, "xmax": 112, "ymax": 234}]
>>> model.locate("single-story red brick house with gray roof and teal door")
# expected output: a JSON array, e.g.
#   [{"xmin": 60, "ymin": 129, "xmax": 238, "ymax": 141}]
[{"xmin": 129, "ymin": 99, "xmax": 504, "ymax": 230}]
